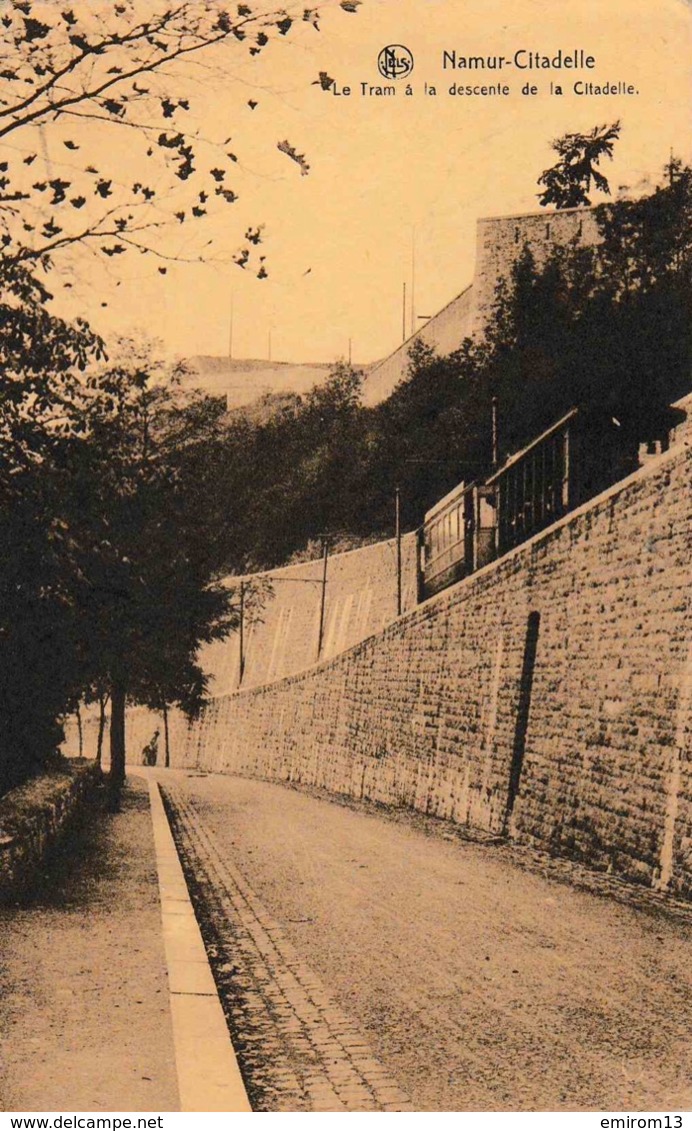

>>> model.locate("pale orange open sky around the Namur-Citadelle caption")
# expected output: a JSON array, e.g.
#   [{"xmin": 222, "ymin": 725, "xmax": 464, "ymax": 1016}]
[{"xmin": 45, "ymin": 0, "xmax": 692, "ymax": 363}]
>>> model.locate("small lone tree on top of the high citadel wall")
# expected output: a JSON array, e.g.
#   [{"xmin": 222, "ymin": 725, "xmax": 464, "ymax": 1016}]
[{"xmin": 538, "ymin": 122, "xmax": 620, "ymax": 208}]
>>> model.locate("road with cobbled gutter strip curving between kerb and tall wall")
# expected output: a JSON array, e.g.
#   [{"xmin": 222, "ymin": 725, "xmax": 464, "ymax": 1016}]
[{"xmin": 162, "ymin": 772, "xmax": 692, "ymax": 1111}]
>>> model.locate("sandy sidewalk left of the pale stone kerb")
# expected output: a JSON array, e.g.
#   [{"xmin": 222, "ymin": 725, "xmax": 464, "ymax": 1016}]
[{"xmin": 0, "ymin": 777, "xmax": 180, "ymax": 1112}]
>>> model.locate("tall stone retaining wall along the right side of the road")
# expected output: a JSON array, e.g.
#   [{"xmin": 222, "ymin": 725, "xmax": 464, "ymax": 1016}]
[{"xmin": 174, "ymin": 443, "xmax": 692, "ymax": 893}]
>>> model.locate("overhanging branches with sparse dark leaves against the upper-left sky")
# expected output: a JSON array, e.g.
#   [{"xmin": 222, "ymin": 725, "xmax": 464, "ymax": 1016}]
[{"xmin": 0, "ymin": 0, "xmax": 364, "ymax": 277}]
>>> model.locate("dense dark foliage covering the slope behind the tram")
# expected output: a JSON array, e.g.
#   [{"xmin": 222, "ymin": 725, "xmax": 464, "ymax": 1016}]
[{"xmin": 207, "ymin": 169, "xmax": 692, "ymax": 568}]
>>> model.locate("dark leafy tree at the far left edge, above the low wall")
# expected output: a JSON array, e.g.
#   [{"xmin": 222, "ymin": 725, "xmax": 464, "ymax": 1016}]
[{"xmin": 0, "ymin": 255, "xmax": 103, "ymax": 792}]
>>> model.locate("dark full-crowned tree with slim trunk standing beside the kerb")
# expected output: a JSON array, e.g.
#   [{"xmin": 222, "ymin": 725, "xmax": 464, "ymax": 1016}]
[{"xmin": 62, "ymin": 343, "xmax": 237, "ymax": 806}]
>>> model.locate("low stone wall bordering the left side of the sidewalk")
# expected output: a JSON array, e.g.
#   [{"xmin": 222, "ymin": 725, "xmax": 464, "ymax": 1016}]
[{"xmin": 0, "ymin": 762, "xmax": 101, "ymax": 901}]
